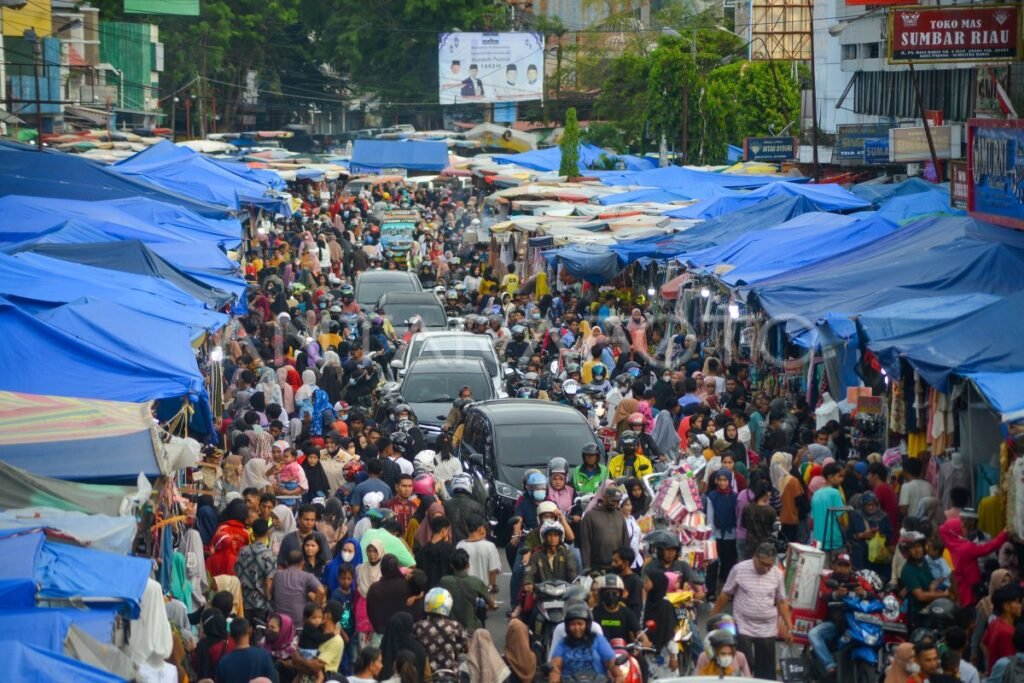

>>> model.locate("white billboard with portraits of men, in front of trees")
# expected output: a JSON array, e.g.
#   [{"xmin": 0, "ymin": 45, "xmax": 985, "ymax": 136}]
[{"xmin": 437, "ymin": 32, "xmax": 544, "ymax": 104}]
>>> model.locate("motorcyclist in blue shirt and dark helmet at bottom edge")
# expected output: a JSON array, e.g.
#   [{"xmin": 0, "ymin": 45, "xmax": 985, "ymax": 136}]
[{"xmin": 548, "ymin": 602, "xmax": 625, "ymax": 683}]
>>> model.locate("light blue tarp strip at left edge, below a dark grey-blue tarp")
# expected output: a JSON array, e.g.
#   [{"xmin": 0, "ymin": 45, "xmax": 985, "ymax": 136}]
[{"xmin": 0, "ymin": 254, "xmax": 228, "ymax": 337}]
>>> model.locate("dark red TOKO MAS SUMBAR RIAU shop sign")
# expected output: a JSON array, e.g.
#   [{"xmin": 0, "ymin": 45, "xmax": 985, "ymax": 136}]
[{"xmin": 889, "ymin": 5, "xmax": 1024, "ymax": 63}]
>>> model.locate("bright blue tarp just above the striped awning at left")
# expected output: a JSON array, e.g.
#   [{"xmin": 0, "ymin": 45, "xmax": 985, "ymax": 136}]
[{"xmin": 0, "ymin": 299, "xmax": 206, "ymax": 402}]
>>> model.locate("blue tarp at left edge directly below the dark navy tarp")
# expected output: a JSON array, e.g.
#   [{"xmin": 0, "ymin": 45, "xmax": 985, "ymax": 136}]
[{"xmin": 0, "ymin": 195, "xmax": 242, "ymax": 249}]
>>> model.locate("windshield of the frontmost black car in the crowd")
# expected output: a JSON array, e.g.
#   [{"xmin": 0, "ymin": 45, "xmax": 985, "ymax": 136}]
[{"xmin": 497, "ymin": 420, "xmax": 597, "ymax": 486}]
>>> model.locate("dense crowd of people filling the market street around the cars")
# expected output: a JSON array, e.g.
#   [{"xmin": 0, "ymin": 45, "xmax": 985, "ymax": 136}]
[{"xmin": 169, "ymin": 178, "xmax": 1024, "ymax": 683}]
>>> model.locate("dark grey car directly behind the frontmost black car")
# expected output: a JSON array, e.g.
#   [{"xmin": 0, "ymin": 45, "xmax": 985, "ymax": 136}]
[{"xmin": 401, "ymin": 357, "xmax": 495, "ymax": 445}]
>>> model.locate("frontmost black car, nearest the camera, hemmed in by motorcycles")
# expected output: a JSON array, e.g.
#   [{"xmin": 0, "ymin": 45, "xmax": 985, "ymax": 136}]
[{"xmin": 458, "ymin": 398, "xmax": 604, "ymax": 543}]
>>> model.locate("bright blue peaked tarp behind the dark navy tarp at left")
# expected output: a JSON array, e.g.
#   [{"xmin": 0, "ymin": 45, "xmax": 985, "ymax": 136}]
[{"xmin": 111, "ymin": 140, "xmax": 291, "ymax": 211}]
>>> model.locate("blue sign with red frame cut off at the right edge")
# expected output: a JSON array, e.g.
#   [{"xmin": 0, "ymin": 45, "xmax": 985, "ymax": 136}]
[{"xmin": 967, "ymin": 119, "xmax": 1024, "ymax": 229}]
